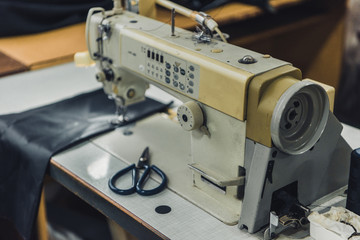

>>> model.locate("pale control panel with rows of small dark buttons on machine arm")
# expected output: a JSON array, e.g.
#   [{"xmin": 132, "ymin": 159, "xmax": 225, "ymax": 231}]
[{"xmin": 121, "ymin": 36, "xmax": 200, "ymax": 99}]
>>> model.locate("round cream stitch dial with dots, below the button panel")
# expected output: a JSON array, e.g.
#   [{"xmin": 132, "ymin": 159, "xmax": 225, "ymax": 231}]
[{"xmin": 177, "ymin": 101, "xmax": 204, "ymax": 131}]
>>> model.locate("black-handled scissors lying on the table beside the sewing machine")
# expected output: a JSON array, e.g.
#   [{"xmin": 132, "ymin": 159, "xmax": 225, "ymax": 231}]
[{"xmin": 109, "ymin": 147, "xmax": 167, "ymax": 196}]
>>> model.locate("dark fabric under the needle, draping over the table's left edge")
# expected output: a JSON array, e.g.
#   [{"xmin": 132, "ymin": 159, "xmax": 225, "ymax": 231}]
[{"xmin": 0, "ymin": 90, "xmax": 167, "ymax": 239}]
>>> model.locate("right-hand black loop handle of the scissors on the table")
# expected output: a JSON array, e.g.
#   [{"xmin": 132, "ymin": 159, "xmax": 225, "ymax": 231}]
[{"xmin": 136, "ymin": 165, "xmax": 167, "ymax": 196}]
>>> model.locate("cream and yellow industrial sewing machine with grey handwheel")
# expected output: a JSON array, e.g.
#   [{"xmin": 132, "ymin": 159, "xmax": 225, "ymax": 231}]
[{"xmin": 81, "ymin": 1, "xmax": 351, "ymax": 238}]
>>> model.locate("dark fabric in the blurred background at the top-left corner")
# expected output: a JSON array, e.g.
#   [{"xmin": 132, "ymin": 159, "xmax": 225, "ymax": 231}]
[{"xmin": 0, "ymin": 0, "xmax": 112, "ymax": 37}]
